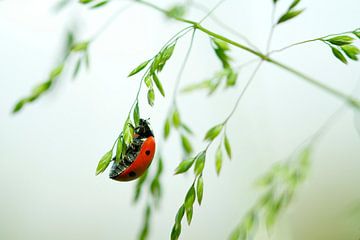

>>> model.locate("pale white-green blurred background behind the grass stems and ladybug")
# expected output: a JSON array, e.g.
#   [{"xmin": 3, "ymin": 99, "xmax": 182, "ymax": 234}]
[{"xmin": 0, "ymin": 0, "xmax": 360, "ymax": 240}]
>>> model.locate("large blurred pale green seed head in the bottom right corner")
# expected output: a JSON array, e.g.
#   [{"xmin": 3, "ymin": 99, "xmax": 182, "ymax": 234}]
[{"xmin": 230, "ymin": 144, "xmax": 312, "ymax": 240}]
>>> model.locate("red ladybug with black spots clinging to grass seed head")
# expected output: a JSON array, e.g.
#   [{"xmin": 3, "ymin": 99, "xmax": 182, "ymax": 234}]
[{"xmin": 109, "ymin": 119, "xmax": 155, "ymax": 181}]
